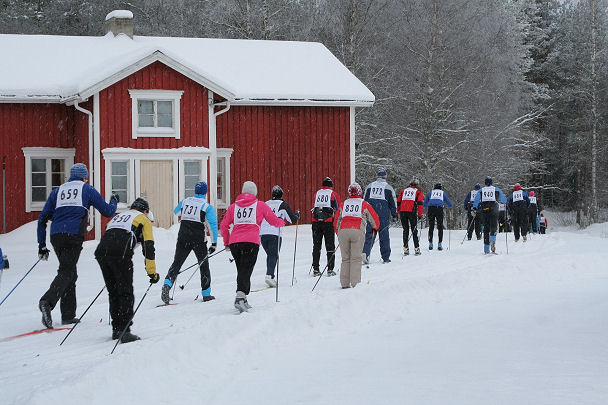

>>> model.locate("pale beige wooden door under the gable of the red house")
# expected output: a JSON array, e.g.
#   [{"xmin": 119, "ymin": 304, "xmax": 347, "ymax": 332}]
[{"xmin": 140, "ymin": 160, "xmax": 174, "ymax": 228}]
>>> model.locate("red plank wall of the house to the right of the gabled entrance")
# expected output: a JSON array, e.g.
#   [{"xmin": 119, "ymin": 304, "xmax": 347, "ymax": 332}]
[{"xmin": 217, "ymin": 106, "xmax": 350, "ymax": 222}]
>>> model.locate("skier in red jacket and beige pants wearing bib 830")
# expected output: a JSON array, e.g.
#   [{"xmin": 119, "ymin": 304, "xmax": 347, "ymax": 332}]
[{"xmin": 336, "ymin": 183, "xmax": 381, "ymax": 288}]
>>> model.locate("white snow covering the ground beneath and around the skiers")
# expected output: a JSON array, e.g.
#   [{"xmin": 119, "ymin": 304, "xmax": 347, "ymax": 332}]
[{"xmin": 0, "ymin": 223, "xmax": 608, "ymax": 405}]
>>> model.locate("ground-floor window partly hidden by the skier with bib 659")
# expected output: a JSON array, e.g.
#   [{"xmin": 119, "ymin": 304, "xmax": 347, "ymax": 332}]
[{"xmin": 22, "ymin": 147, "xmax": 75, "ymax": 212}]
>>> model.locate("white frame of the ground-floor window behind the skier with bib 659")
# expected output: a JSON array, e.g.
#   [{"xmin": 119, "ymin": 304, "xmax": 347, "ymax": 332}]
[{"xmin": 21, "ymin": 147, "xmax": 76, "ymax": 212}]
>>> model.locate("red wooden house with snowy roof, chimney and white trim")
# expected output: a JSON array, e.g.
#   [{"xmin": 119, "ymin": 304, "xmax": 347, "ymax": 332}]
[{"xmin": 0, "ymin": 12, "xmax": 374, "ymax": 238}]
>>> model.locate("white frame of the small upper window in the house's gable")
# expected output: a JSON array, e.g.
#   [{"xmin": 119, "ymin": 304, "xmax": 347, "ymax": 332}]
[{"xmin": 129, "ymin": 90, "xmax": 184, "ymax": 139}]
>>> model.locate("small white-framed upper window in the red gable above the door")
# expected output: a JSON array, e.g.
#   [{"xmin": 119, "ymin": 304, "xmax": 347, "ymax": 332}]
[{"xmin": 129, "ymin": 90, "xmax": 183, "ymax": 139}]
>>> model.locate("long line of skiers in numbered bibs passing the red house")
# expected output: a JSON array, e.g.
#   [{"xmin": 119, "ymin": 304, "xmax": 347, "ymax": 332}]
[{"xmin": 32, "ymin": 163, "xmax": 546, "ymax": 343}]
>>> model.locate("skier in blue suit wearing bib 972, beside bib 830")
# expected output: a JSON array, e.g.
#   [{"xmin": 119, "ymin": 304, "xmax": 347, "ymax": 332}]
[{"xmin": 362, "ymin": 167, "xmax": 398, "ymax": 264}]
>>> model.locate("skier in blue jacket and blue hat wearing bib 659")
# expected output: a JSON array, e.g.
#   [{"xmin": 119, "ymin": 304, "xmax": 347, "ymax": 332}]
[{"xmin": 38, "ymin": 163, "xmax": 119, "ymax": 329}]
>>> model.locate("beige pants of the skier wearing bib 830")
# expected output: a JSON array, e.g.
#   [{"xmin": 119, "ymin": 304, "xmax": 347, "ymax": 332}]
[{"xmin": 338, "ymin": 229, "xmax": 365, "ymax": 287}]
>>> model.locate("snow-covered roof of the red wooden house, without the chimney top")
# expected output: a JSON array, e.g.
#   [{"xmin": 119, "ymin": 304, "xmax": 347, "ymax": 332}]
[{"xmin": 0, "ymin": 33, "xmax": 374, "ymax": 105}]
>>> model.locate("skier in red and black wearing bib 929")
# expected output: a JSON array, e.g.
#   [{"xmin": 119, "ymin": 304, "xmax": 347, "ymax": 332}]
[{"xmin": 397, "ymin": 179, "xmax": 424, "ymax": 256}]
